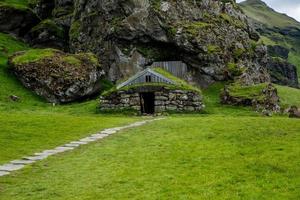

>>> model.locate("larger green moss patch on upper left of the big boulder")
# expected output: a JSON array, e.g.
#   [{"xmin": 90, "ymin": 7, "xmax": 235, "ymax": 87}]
[{"xmin": 12, "ymin": 49, "xmax": 56, "ymax": 65}]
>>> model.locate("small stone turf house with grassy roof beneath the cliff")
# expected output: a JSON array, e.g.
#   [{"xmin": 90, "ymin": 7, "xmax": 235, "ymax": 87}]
[{"xmin": 100, "ymin": 67, "xmax": 204, "ymax": 114}]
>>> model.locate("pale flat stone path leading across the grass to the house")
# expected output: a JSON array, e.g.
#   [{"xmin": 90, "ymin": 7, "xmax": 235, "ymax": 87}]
[{"xmin": 0, "ymin": 118, "xmax": 164, "ymax": 177}]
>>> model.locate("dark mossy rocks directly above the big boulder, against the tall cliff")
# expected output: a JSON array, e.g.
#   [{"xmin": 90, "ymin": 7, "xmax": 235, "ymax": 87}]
[{"xmin": 25, "ymin": 0, "xmax": 73, "ymax": 51}]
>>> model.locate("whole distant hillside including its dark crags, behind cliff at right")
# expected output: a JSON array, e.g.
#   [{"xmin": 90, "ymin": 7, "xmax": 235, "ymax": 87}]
[{"xmin": 240, "ymin": 0, "xmax": 300, "ymax": 87}]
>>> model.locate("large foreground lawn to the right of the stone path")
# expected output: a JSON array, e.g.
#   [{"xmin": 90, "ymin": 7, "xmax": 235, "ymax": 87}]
[{"xmin": 0, "ymin": 116, "xmax": 300, "ymax": 200}]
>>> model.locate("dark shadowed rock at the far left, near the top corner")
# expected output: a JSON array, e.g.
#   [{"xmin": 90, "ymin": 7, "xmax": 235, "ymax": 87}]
[{"xmin": 0, "ymin": 2, "xmax": 40, "ymax": 36}]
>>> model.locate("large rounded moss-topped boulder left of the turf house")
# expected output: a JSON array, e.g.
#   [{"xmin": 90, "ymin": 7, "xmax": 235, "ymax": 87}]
[{"xmin": 9, "ymin": 49, "xmax": 104, "ymax": 103}]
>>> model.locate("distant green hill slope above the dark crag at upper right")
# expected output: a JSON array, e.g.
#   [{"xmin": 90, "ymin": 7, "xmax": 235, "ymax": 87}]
[{"xmin": 240, "ymin": 0, "xmax": 300, "ymax": 81}]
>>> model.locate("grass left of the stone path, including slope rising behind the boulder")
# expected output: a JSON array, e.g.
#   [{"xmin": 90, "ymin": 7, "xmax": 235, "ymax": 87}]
[{"xmin": 0, "ymin": 32, "xmax": 138, "ymax": 164}]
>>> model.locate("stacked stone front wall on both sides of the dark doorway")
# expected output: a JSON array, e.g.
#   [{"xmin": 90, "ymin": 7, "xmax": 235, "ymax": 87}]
[{"xmin": 100, "ymin": 90, "xmax": 204, "ymax": 113}]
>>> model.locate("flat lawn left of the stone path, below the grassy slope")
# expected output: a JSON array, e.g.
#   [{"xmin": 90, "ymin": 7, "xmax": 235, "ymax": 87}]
[{"xmin": 0, "ymin": 111, "xmax": 137, "ymax": 164}]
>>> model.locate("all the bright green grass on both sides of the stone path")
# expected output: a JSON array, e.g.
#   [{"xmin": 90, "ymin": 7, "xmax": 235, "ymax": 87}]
[{"xmin": 0, "ymin": 34, "xmax": 300, "ymax": 200}]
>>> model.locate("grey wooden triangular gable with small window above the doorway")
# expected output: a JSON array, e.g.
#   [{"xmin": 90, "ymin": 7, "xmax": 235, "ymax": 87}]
[{"xmin": 117, "ymin": 68, "xmax": 175, "ymax": 89}]
